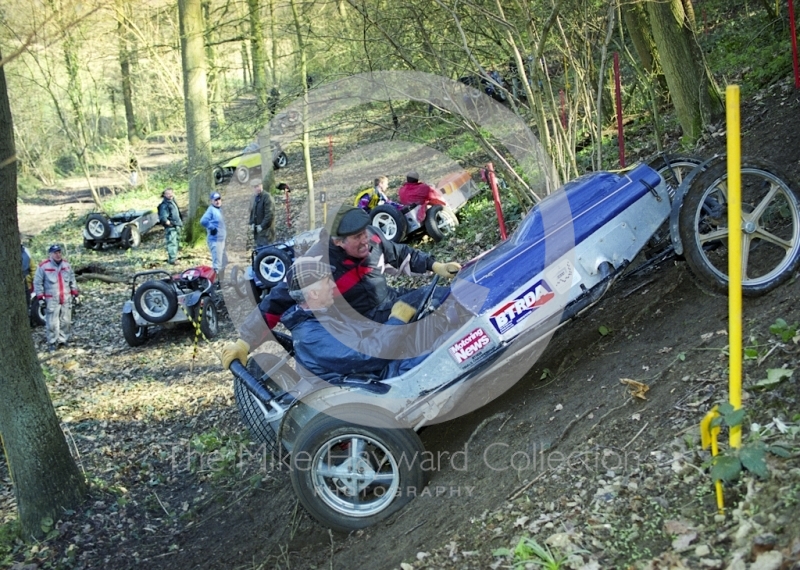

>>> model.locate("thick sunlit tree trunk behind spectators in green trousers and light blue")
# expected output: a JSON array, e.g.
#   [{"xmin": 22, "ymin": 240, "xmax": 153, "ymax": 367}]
[{"xmin": 178, "ymin": 0, "xmax": 214, "ymax": 222}]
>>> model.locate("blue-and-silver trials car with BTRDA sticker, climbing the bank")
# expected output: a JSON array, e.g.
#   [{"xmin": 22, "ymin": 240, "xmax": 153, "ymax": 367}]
[{"xmin": 231, "ymin": 156, "xmax": 800, "ymax": 532}]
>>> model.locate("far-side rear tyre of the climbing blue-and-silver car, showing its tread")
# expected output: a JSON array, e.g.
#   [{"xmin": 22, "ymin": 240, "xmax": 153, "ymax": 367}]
[{"xmin": 233, "ymin": 353, "xmax": 300, "ymax": 451}]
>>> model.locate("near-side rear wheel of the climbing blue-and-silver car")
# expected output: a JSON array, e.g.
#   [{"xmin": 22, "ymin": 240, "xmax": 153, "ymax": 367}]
[{"xmin": 291, "ymin": 406, "xmax": 426, "ymax": 532}]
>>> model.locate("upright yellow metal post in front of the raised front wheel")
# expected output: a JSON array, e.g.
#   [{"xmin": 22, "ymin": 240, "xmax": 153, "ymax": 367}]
[{"xmin": 725, "ymin": 85, "xmax": 742, "ymax": 447}]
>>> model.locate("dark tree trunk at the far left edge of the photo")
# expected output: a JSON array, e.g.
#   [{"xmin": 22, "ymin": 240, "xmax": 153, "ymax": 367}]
[{"xmin": 0, "ymin": 50, "xmax": 86, "ymax": 538}]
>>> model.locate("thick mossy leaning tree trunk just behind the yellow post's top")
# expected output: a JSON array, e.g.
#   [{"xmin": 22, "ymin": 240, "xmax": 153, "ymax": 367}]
[{"xmin": 647, "ymin": 0, "xmax": 722, "ymax": 143}]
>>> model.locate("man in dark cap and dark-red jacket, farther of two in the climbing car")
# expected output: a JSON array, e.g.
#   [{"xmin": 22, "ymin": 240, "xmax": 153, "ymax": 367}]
[{"xmin": 226, "ymin": 207, "xmax": 461, "ymax": 360}]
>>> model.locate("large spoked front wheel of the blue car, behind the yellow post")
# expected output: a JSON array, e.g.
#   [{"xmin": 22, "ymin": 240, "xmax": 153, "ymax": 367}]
[{"xmin": 678, "ymin": 159, "xmax": 800, "ymax": 297}]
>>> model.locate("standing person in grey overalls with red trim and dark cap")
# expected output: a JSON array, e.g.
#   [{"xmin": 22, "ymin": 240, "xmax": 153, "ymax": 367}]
[{"xmin": 33, "ymin": 245, "xmax": 78, "ymax": 352}]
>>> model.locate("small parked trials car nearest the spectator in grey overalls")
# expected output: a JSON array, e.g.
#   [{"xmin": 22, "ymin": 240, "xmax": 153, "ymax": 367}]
[{"xmin": 122, "ymin": 265, "xmax": 221, "ymax": 346}]
